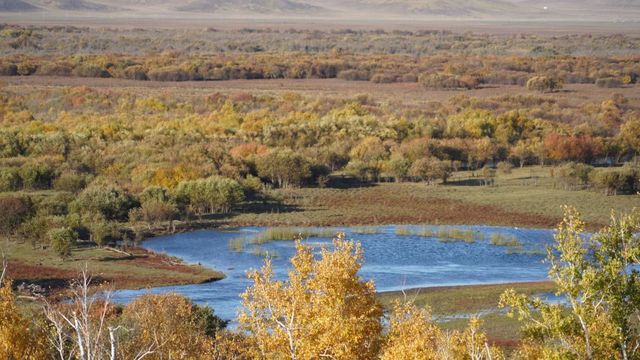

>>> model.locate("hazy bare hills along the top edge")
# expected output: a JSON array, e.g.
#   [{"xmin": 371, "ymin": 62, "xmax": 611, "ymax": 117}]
[{"xmin": 0, "ymin": 0, "xmax": 640, "ymax": 21}]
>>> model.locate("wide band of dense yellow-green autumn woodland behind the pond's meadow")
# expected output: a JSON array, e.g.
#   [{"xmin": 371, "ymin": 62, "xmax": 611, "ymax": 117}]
[{"xmin": 0, "ymin": 79, "xmax": 640, "ymax": 252}]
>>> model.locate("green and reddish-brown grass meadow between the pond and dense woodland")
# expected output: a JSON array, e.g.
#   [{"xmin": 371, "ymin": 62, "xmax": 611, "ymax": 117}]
[{"xmin": 227, "ymin": 166, "xmax": 640, "ymax": 229}]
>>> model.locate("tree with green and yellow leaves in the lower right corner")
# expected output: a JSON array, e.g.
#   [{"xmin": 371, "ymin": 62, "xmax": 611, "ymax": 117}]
[{"xmin": 500, "ymin": 207, "xmax": 640, "ymax": 359}]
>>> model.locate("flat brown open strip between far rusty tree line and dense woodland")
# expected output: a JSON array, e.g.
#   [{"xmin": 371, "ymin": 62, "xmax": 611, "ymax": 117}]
[{"xmin": 5, "ymin": 76, "xmax": 640, "ymax": 108}]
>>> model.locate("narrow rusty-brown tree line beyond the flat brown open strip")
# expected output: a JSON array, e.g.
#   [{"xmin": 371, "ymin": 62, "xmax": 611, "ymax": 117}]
[{"xmin": 0, "ymin": 51, "xmax": 640, "ymax": 89}]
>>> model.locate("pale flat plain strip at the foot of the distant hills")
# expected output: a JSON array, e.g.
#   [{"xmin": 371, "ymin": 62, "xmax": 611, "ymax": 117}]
[{"xmin": 0, "ymin": 13, "xmax": 640, "ymax": 35}]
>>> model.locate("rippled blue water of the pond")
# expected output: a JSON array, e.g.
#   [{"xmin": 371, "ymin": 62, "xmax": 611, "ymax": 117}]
[{"xmin": 113, "ymin": 226, "xmax": 553, "ymax": 319}]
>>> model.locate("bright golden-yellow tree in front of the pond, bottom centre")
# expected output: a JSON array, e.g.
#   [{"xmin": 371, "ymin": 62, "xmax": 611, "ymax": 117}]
[{"xmin": 239, "ymin": 234, "xmax": 382, "ymax": 359}]
